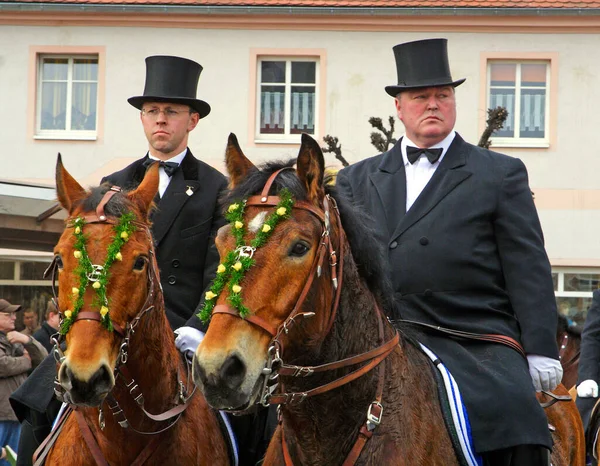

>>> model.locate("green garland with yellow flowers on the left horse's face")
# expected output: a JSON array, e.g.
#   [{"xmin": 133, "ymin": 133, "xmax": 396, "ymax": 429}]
[{"xmin": 60, "ymin": 213, "xmax": 136, "ymax": 335}]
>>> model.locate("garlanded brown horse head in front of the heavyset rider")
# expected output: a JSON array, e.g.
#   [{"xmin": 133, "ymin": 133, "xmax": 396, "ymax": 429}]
[{"xmin": 193, "ymin": 134, "xmax": 341, "ymax": 410}]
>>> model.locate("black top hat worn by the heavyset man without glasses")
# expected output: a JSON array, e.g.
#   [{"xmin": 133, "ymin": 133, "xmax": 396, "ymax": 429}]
[{"xmin": 385, "ymin": 39, "xmax": 466, "ymax": 97}]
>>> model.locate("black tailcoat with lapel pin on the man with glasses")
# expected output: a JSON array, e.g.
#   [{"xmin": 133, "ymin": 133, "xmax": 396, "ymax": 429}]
[{"xmin": 102, "ymin": 149, "xmax": 227, "ymax": 329}]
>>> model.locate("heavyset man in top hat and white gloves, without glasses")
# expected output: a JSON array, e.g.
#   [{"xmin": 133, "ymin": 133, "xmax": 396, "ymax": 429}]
[{"xmin": 337, "ymin": 39, "xmax": 562, "ymax": 466}]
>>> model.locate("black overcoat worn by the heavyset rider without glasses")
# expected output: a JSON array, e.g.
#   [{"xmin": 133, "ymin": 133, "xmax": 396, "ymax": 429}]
[{"xmin": 337, "ymin": 134, "xmax": 558, "ymax": 453}]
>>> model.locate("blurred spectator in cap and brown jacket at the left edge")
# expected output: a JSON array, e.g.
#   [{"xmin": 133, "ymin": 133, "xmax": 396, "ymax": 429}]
[{"xmin": 0, "ymin": 299, "xmax": 48, "ymax": 466}]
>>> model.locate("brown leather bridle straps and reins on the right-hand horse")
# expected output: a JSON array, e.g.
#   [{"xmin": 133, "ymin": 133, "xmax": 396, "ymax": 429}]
[{"xmin": 213, "ymin": 167, "xmax": 400, "ymax": 466}]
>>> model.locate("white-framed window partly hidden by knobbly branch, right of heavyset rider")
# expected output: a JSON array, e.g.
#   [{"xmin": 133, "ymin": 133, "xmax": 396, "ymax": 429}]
[{"xmin": 488, "ymin": 60, "xmax": 550, "ymax": 147}]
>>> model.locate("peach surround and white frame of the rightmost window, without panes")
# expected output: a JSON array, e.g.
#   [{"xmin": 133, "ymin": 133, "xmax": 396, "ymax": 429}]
[{"xmin": 479, "ymin": 52, "xmax": 559, "ymax": 149}]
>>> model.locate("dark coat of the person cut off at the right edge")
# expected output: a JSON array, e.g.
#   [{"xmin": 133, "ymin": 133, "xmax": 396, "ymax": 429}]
[{"xmin": 577, "ymin": 290, "xmax": 600, "ymax": 429}]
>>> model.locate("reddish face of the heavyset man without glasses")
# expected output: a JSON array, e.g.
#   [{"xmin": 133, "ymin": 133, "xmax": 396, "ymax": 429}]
[{"xmin": 394, "ymin": 86, "xmax": 456, "ymax": 148}]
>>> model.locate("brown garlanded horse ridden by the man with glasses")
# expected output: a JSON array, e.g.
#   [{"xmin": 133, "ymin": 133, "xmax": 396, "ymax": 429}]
[{"xmin": 39, "ymin": 156, "xmax": 229, "ymax": 466}]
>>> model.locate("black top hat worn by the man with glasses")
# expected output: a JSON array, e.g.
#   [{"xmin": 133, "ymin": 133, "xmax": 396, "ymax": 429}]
[{"xmin": 127, "ymin": 55, "xmax": 210, "ymax": 118}]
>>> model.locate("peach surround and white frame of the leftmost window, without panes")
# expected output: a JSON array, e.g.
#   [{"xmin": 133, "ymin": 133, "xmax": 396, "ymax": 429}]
[{"xmin": 27, "ymin": 45, "xmax": 106, "ymax": 142}]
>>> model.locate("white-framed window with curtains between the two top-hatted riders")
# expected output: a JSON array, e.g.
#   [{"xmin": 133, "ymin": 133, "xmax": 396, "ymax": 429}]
[{"xmin": 256, "ymin": 57, "xmax": 319, "ymax": 142}]
